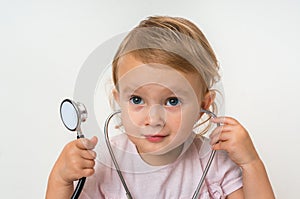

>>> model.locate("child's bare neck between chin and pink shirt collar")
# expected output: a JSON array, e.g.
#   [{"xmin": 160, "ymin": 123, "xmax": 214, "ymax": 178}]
[{"xmin": 140, "ymin": 144, "xmax": 183, "ymax": 166}]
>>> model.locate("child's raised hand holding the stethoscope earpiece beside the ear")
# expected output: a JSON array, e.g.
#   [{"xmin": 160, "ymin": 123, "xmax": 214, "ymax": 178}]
[{"xmin": 210, "ymin": 117, "xmax": 259, "ymax": 167}]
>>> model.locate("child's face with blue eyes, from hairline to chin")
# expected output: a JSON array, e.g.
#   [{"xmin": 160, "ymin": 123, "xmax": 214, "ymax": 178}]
[{"xmin": 114, "ymin": 55, "xmax": 207, "ymax": 160}]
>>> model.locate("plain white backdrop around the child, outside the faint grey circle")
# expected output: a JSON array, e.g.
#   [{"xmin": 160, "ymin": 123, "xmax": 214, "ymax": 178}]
[{"xmin": 0, "ymin": 0, "xmax": 300, "ymax": 199}]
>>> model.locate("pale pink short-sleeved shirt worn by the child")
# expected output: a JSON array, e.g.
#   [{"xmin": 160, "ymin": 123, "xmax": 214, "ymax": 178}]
[{"xmin": 80, "ymin": 134, "xmax": 242, "ymax": 199}]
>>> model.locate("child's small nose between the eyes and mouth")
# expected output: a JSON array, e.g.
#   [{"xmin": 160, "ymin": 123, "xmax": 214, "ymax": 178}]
[{"xmin": 145, "ymin": 104, "xmax": 166, "ymax": 126}]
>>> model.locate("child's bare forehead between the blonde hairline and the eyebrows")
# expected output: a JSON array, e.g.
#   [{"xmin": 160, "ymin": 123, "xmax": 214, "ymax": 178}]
[{"xmin": 117, "ymin": 55, "xmax": 201, "ymax": 96}]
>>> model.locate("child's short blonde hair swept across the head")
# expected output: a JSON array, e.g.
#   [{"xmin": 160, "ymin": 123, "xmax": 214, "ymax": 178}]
[{"xmin": 112, "ymin": 16, "xmax": 220, "ymax": 133}]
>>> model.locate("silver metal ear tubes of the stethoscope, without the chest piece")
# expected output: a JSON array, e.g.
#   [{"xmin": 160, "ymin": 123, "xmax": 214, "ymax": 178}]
[{"xmin": 104, "ymin": 109, "xmax": 220, "ymax": 199}]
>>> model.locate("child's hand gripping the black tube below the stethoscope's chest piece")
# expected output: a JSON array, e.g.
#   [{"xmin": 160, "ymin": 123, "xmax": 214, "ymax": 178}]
[{"xmin": 52, "ymin": 137, "xmax": 98, "ymax": 185}]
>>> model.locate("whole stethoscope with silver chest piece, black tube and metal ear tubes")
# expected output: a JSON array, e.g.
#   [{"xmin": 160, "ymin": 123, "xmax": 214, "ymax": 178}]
[{"xmin": 60, "ymin": 99, "xmax": 220, "ymax": 199}]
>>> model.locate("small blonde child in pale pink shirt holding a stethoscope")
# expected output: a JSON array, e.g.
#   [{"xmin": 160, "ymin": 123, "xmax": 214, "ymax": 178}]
[{"xmin": 46, "ymin": 16, "xmax": 274, "ymax": 199}]
